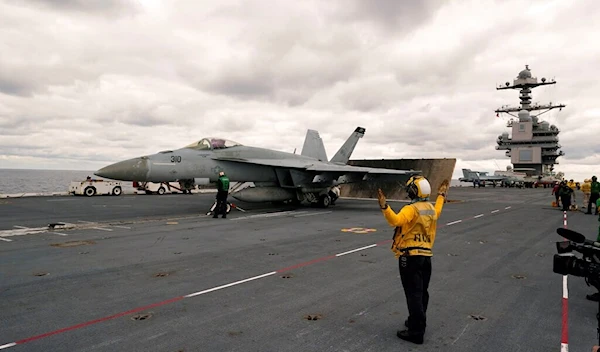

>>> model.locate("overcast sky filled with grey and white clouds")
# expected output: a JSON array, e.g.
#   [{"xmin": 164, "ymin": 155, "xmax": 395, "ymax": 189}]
[{"xmin": 0, "ymin": 0, "xmax": 600, "ymax": 180}]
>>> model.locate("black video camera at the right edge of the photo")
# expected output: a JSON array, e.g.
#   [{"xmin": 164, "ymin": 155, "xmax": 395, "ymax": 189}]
[{"xmin": 552, "ymin": 228, "xmax": 600, "ymax": 290}]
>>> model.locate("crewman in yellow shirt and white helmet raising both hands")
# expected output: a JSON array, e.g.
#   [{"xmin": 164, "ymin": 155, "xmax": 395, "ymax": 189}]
[{"xmin": 378, "ymin": 176, "xmax": 449, "ymax": 344}]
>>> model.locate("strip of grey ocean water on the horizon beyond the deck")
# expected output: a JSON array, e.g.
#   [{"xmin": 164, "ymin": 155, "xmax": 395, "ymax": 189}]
[{"xmin": 0, "ymin": 169, "xmax": 473, "ymax": 194}]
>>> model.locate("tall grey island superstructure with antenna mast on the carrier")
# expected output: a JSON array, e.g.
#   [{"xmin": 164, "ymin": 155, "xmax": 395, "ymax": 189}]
[{"xmin": 495, "ymin": 65, "xmax": 565, "ymax": 179}]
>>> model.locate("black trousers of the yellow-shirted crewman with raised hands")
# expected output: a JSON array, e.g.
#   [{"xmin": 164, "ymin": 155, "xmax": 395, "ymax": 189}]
[{"xmin": 398, "ymin": 255, "xmax": 431, "ymax": 334}]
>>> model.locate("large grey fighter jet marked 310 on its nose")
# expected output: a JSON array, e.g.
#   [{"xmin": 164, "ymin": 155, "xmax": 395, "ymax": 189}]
[{"xmin": 95, "ymin": 127, "xmax": 421, "ymax": 208}]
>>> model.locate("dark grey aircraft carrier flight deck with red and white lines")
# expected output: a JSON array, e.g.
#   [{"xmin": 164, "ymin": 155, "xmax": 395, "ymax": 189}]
[{"xmin": 0, "ymin": 188, "xmax": 598, "ymax": 352}]
